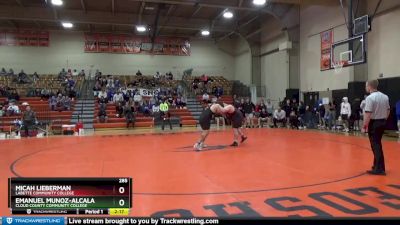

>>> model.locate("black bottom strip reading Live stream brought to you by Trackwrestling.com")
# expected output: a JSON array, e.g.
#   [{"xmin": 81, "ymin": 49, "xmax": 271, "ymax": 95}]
[{"xmin": 65, "ymin": 217, "xmax": 400, "ymax": 225}]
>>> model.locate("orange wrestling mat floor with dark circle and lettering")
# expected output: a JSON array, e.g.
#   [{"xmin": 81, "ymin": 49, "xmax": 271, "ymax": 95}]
[{"xmin": 0, "ymin": 129, "xmax": 400, "ymax": 217}]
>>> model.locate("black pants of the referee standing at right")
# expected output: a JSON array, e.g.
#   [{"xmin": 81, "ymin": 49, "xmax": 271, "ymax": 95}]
[{"xmin": 368, "ymin": 119, "xmax": 386, "ymax": 172}]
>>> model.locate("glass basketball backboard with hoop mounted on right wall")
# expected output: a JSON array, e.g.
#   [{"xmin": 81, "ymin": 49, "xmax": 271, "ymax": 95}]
[{"xmin": 331, "ymin": 35, "xmax": 366, "ymax": 68}]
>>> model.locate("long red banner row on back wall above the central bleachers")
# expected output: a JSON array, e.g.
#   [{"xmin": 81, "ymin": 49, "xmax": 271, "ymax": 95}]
[{"xmin": 84, "ymin": 34, "xmax": 190, "ymax": 56}]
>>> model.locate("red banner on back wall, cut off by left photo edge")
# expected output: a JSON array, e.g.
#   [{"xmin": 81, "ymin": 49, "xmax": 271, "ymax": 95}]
[{"xmin": 0, "ymin": 30, "xmax": 50, "ymax": 47}]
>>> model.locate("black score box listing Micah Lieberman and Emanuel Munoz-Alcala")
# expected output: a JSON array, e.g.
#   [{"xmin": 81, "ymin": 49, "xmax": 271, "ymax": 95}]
[{"xmin": 8, "ymin": 178, "xmax": 132, "ymax": 214}]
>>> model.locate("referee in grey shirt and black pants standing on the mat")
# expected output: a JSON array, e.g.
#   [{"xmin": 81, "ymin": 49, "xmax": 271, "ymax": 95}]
[{"xmin": 363, "ymin": 80, "xmax": 390, "ymax": 176}]
